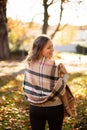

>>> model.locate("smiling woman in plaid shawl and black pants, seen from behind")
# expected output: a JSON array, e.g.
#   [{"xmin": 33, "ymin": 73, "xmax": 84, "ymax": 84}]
[{"xmin": 24, "ymin": 35, "xmax": 71, "ymax": 130}]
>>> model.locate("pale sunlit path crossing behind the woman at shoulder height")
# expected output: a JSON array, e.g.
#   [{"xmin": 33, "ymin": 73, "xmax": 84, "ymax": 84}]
[{"xmin": 0, "ymin": 54, "xmax": 87, "ymax": 77}]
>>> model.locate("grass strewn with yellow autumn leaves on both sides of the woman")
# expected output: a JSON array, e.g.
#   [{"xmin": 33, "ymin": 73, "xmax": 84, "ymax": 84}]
[{"xmin": 0, "ymin": 69, "xmax": 87, "ymax": 130}]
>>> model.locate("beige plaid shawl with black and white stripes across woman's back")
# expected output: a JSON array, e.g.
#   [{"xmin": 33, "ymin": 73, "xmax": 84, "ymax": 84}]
[{"xmin": 23, "ymin": 58, "xmax": 65, "ymax": 105}]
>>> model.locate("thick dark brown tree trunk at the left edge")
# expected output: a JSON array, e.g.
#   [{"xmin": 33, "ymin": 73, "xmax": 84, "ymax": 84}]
[{"xmin": 0, "ymin": 0, "xmax": 9, "ymax": 60}]
